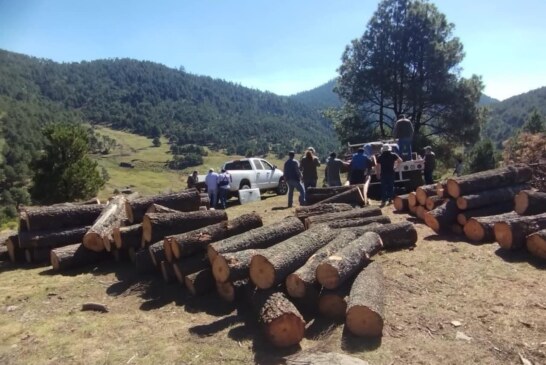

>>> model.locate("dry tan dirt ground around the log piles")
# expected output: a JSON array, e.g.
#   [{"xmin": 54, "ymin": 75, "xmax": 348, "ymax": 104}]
[{"xmin": 0, "ymin": 196, "xmax": 546, "ymax": 365}]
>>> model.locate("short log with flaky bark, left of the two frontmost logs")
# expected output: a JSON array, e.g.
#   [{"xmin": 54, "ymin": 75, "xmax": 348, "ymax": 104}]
[{"xmin": 252, "ymin": 290, "xmax": 305, "ymax": 347}]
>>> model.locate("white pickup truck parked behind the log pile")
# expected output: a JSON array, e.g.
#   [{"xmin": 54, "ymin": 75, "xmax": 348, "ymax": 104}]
[{"xmin": 222, "ymin": 158, "xmax": 288, "ymax": 195}]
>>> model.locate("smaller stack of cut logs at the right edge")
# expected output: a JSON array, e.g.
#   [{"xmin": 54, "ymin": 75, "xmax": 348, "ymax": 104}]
[{"xmin": 394, "ymin": 165, "xmax": 546, "ymax": 259}]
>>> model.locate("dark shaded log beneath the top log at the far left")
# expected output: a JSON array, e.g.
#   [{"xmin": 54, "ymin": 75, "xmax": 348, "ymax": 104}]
[{"xmin": 19, "ymin": 226, "xmax": 90, "ymax": 249}]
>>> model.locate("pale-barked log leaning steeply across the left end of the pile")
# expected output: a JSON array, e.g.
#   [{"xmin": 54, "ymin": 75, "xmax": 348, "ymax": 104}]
[{"xmin": 82, "ymin": 195, "xmax": 127, "ymax": 252}]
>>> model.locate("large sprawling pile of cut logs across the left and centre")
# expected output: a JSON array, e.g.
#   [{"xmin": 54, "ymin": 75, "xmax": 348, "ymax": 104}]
[{"xmin": 3, "ymin": 185, "xmax": 417, "ymax": 347}]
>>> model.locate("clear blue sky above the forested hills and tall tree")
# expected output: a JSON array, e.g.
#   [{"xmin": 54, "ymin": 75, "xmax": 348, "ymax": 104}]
[{"xmin": 0, "ymin": 0, "xmax": 546, "ymax": 100}]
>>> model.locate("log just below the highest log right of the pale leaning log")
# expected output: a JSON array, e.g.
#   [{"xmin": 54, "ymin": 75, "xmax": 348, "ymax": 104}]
[{"xmin": 142, "ymin": 210, "xmax": 227, "ymax": 243}]
